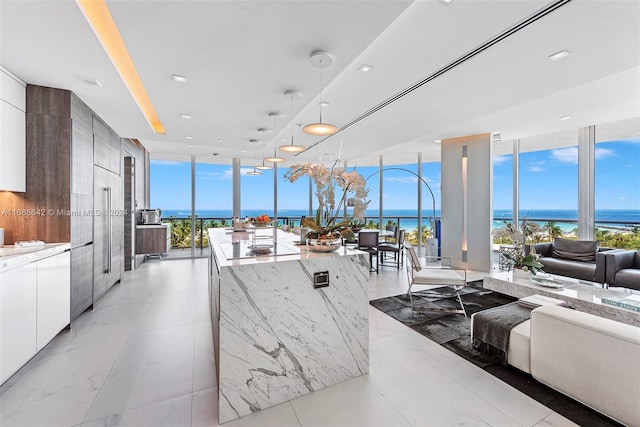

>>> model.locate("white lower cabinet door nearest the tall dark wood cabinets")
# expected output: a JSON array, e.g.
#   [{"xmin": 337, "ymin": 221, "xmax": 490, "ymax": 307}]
[{"xmin": 36, "ymin": 252, "xmax": 71, "ymax": 351}]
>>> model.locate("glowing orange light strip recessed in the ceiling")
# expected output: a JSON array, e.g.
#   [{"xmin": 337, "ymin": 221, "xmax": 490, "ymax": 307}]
[{"xmin": 76, "ymin": 0, "xmax": 165, "ymax": 135}]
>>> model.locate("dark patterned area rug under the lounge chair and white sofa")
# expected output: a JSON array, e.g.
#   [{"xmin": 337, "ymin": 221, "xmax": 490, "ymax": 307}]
[{"xmin": 370, "ymin": 281, "xmax": 620, "ymax": 426}]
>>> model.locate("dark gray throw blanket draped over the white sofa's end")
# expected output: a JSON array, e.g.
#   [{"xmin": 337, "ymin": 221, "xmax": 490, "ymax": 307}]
[{"xmin": 473, "ymin": 301, "xmax": 531, "ymax": 364}]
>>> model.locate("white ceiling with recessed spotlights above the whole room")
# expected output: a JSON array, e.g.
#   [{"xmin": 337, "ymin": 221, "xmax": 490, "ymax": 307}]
[{"xmin": 0, "ymin": 0, "xmax": 640, "ymax": 165}]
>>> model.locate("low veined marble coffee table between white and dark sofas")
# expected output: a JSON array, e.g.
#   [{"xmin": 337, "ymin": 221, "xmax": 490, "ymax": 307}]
[{"xmin": 483, "ymin": 272, "xmax": 640, "ymax": 326}]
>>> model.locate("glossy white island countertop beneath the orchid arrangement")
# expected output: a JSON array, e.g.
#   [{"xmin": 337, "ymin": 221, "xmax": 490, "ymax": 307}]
[{"xmin": 208, "ymin": 227, "xmax": 364, "ymax": 267}]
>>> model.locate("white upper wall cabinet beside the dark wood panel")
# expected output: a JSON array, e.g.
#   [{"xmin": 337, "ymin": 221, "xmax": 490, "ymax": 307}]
[{"xmin": 0, "ymin": 67, "xmax": 27, "ymax": 192}]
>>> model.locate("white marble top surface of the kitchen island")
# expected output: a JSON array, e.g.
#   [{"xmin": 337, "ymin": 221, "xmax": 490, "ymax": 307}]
[{"xmin": 208, "ymin": 227, "xmax": 364, "ymax": 266}]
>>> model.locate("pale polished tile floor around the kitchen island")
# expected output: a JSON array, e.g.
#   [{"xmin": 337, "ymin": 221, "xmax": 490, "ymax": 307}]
[{"xmin": 0, "ymin": 259, "xmax": 574, "ymax": 427}]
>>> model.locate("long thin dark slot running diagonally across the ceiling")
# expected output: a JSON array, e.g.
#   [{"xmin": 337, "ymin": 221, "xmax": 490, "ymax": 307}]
[{"xmin": 296, "ymin": 0, "xmax": 573, "ymax": 156}]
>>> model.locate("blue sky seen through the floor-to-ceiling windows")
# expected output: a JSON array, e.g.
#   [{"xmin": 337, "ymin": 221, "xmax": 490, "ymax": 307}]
[{"xmin": 150, "ymin": 138, "xmax": 640, "ymax": 211}]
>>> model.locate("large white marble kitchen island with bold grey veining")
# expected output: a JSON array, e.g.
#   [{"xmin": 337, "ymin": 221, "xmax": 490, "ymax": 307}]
[{"xmin": 208, "ymin": 229, "xmax": 369, "ymax": 423}]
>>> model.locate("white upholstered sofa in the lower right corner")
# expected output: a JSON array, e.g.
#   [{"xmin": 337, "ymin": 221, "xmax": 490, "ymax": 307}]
[{"xmin": 507, "ymin": 305, "xmax": 640, "ymax": 426}]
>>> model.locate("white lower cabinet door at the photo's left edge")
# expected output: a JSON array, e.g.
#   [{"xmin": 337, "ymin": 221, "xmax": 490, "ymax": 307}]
[{"xmin": 0, "ymin": 263, "xmax": 37, "ymax": 383}]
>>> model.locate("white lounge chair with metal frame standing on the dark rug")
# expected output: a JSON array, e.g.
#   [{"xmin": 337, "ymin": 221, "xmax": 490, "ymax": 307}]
[{"xmin": 405, "ymin": 242, "xmax": 468, "ymax": 317}]
